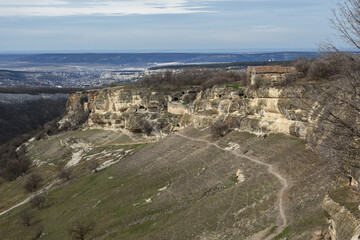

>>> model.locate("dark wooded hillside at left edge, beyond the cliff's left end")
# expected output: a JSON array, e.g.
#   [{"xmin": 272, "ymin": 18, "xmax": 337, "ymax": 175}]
[{"xmin": 0, "ymin": 88, "xmax": 83, "ymax": 144}]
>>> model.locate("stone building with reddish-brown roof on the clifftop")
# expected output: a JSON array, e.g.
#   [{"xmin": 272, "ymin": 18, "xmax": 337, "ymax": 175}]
[{"xmin": 246, "ymin": 65, "xmax": 296, "ymax": 85}]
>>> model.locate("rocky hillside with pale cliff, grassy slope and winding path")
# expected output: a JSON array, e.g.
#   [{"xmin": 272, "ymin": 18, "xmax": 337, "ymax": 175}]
[{"xmin": 0, "ymin": 54, "xmax": 360, "ymax": 240}]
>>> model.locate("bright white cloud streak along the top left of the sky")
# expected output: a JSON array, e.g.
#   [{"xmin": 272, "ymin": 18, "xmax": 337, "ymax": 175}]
[{"xmin": 0, "ymin": 0, "xmax": 212, "ymax": 17}]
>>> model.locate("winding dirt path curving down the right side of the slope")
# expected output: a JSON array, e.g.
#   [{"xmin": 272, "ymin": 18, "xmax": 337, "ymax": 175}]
[{"xmin": 175, "ymin": 133, "xmax": 288, "ymax": 240}]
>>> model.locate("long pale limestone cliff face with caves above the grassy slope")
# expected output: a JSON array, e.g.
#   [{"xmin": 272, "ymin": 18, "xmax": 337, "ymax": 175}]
[{"xmin": 60, "ymin": 86, "xmax": 309, "ymax": 138}]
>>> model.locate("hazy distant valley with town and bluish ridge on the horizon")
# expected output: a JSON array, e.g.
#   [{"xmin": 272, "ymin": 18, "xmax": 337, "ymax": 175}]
[{"xmin": 0, "ymin": 52, "xmax": 318, "ymax": 87}]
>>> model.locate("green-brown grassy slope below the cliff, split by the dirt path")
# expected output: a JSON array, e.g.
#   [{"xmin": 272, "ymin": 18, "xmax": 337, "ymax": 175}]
[{"xmin": 0, "ymin": 129, "xmax": 334, "ymax": 239}]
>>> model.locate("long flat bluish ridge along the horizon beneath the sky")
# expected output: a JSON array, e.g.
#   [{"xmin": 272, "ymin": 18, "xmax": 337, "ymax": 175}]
[{"xmin": 0, "ymin": 52, "xmax": 318, "ymax": 68}]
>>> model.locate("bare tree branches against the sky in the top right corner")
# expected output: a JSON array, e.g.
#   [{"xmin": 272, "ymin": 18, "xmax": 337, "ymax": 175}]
[{"xmin": 330, "ymin": 0, "xmax": 360, "ymax": 49}]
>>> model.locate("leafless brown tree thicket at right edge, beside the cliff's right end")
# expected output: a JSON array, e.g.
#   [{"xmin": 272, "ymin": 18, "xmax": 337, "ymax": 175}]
[{"xmin": 292, "ymin": 52, "xmax": 360, "ymax": 181}]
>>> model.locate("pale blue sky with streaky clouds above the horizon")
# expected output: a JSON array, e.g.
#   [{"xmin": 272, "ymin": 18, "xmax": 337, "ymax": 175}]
[{"xmin": 0, "ymin": 0, "xmax": 344, "ymax": 53}]
